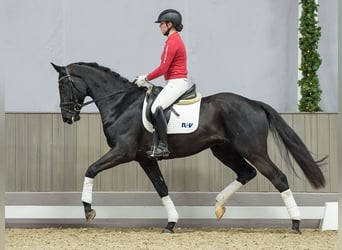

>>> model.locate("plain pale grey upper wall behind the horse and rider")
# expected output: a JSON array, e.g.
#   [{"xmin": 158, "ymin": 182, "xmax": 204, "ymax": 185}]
[{"xmin": 1, "ymin": 0, "xmax": 337, "ymax": 112}]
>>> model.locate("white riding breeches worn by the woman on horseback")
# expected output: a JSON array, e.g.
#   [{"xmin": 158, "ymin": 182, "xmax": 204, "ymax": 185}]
[{"xmin": 151, "ymin": 78, "xmax": 191, "ymax": 114}]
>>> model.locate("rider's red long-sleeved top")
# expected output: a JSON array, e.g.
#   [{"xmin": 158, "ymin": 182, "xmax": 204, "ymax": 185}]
[{"xmin": 147, "ymin": 32, "xmax": 188, "ymax": 81}]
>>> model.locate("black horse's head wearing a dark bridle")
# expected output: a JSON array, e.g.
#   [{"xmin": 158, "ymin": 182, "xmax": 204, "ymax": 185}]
[{"xmin": 51, "ymin": 63, "xmax": 86, "ymax": 124}]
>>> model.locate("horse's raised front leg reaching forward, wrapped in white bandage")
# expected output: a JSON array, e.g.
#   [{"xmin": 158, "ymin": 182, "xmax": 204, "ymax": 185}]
[{"xmin": 82, "ymin": 148, "xmax": 132, "ymax": 223}]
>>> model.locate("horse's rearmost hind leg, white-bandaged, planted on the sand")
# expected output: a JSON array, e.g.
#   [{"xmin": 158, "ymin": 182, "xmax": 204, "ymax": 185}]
[{"xmin": 248, "ymin": 153, "xmax": 301, "ymax": 233}]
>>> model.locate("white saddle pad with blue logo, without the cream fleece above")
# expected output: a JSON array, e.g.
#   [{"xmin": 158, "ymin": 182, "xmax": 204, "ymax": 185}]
[{"xmin": 142, "ymin": 95, "xmax": 201, "ymax": 134}]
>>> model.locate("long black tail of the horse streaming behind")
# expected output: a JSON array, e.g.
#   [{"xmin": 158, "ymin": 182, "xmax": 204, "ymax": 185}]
[{"xmin": 259, "ymin": 102, "xmax": 327, "ymax": 188}]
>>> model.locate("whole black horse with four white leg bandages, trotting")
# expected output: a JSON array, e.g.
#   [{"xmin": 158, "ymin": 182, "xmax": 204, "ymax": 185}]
[{"xmin": 52, "ymin": 62, "xmax": 325, "ymax": 232}]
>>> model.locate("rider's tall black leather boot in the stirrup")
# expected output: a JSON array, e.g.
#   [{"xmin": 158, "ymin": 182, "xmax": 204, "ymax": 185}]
[{"xmin": 147, "ymin": 106, "xmax": 170, "ymax": 158}]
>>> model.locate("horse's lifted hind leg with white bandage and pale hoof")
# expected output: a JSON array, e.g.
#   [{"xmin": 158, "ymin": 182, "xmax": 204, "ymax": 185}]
[{"xmin": 211, "ymin": 143, "xmax": 257, "ymax": 220}]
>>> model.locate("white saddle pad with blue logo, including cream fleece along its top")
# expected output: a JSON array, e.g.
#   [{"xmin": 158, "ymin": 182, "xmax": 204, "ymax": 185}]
[{"xmin": 142, "ymin": 85, "xmax": 201, "ymax": 134}]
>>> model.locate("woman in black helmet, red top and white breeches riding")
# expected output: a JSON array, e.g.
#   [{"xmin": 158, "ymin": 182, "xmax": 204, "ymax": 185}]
[{"xmin": 135, "ymin": 9, "xmax": 190, "ymax": 158}]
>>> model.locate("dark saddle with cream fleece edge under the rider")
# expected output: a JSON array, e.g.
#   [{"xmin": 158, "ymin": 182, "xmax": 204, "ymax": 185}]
[{"xmin": 146, "ymin": 84, "xmax": 200, "ymax": 126}]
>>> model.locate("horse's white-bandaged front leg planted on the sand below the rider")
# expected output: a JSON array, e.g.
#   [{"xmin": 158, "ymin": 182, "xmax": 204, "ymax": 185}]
[{"xmin": 139, "ymin": 158, "xmax": 179, "ymax": 233}]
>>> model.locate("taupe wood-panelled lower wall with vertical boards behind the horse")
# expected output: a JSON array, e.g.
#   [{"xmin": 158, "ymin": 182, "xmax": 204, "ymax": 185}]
[{"xmin": 6, "ymin": 113, "xmax": 338, "ymax": 192}]
